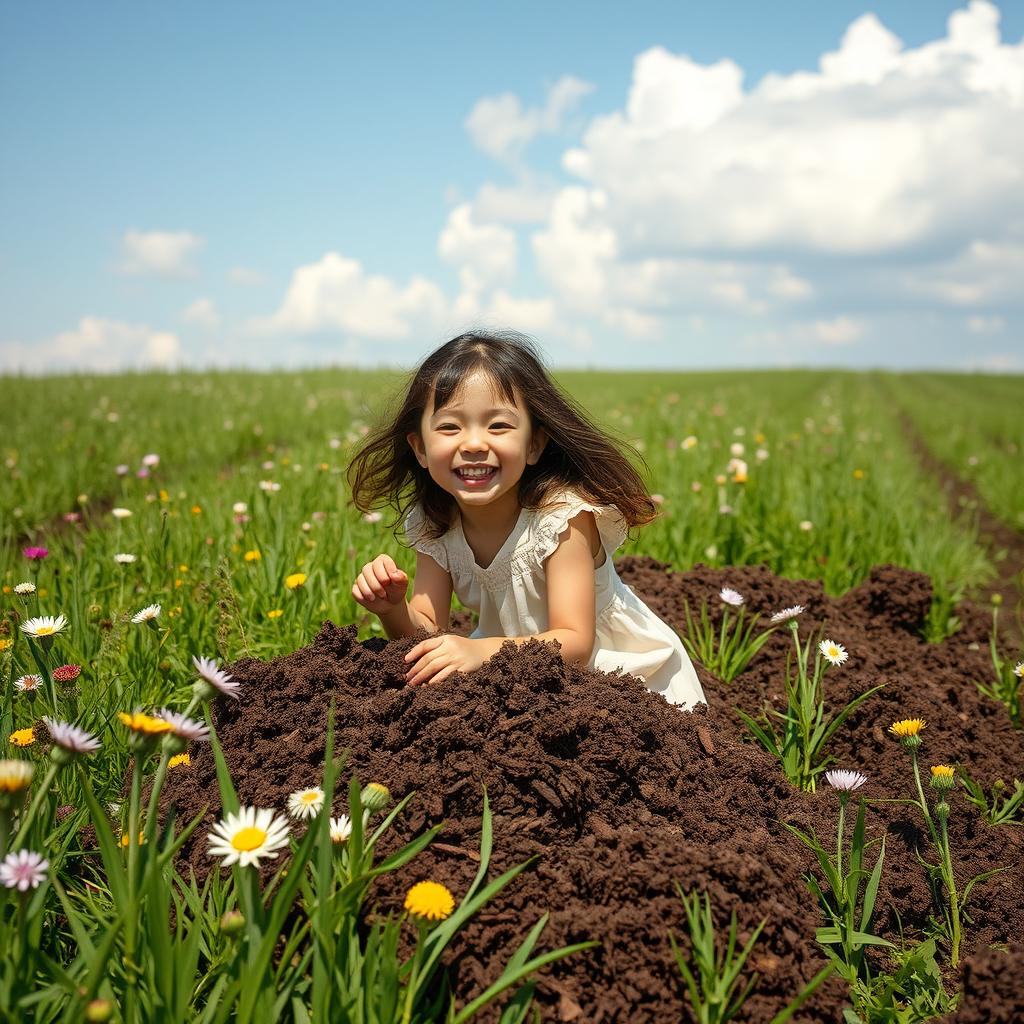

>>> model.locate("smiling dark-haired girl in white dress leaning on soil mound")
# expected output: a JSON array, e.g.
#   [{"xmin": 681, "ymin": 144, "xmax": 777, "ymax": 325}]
[{"xmin": 348, "ymin": 332, "xmax": 703, "ymax": 708}]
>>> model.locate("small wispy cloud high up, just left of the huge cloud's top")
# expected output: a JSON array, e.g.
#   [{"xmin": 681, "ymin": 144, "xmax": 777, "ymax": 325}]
[{"xmin": 466, "ymin": 75, "xmax": 594, "ymax": 165}]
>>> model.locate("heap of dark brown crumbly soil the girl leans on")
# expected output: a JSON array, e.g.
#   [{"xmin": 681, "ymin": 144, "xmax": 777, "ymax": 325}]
[{"xmin": 161, "ymin": 558, "xmax": 1024, "ymax": 1024}]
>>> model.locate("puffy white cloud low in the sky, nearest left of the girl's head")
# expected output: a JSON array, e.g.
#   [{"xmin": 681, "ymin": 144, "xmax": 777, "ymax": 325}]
[{"xmin": 249, "ymin": 252, "xmax": 447, "ymax": 340}]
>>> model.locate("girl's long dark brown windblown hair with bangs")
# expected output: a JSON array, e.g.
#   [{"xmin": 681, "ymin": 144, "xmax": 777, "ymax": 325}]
[{"xmin": 347, "ymin": 331, "xmax": 656, "ymax": 538}]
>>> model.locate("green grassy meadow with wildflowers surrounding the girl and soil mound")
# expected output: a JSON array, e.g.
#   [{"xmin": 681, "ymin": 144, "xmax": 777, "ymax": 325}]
[{"xmin": 0, "ymin": 370, "xmax": 1024, "ymax": 1024}]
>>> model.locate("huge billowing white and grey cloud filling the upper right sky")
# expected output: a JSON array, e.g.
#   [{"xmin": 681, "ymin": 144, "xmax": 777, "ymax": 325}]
[{"xmin": 497, "ymin": 0, "xmax": 1024, "ymax": 346}]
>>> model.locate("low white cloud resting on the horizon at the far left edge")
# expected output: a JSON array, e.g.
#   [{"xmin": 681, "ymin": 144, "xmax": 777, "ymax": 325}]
[{"xmin": 0, "ymin": 316, "xmax": 181, "ymax": 373}]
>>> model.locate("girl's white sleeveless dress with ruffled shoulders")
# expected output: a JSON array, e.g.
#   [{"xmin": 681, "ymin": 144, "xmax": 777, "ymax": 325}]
[{"xmin": 404, "ymin": 490, "xmax": 705, "ymax": 709}]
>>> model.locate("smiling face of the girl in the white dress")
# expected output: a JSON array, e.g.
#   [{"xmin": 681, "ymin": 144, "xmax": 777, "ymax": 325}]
[{"xmin": 408, "ymin": 371, "xmax": 548, "ymax": 508}]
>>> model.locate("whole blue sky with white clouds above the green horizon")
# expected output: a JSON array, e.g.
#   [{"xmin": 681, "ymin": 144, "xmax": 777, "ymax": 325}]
[{"xmin": 0, "ymin": 0, "xmax": 1024, "ymax": 372}]
